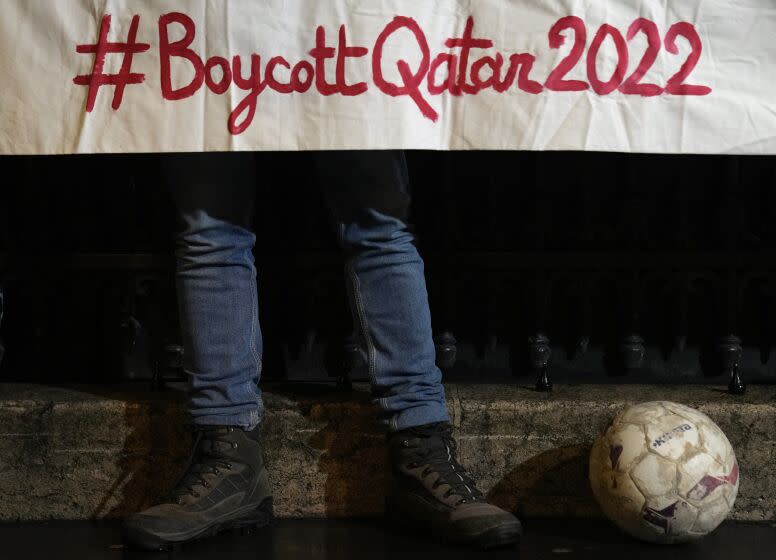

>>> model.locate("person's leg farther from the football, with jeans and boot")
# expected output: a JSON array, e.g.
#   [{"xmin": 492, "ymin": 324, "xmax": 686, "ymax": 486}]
[{"xmin": 124, "ymin": 154, "xmax": 272, "ymax": 549}]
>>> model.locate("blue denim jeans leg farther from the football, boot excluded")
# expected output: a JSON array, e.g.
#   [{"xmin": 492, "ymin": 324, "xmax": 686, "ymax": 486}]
[{"xmin": 162, "ymin": 154, "xmax": 262, "ymax": 429}]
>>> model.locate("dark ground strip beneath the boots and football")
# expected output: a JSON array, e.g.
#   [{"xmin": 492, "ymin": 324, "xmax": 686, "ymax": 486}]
[{"xmin": 0, "ymin": 520, "xmax": 776, "ymax": 560}]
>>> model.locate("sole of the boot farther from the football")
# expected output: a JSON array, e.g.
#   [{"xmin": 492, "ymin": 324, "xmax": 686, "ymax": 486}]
[{"xmin": 124, "ymin": 498, "xmax": 274, "ymax": 551}]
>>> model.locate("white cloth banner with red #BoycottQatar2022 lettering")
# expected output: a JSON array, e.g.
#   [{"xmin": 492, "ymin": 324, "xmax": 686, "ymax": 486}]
[{"xmin": 0, "ymin": 0, "xmax": 776, "ymax": 154}]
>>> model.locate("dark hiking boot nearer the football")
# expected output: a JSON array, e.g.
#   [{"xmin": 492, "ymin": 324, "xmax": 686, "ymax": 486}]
[{"xmin": 386, "ymin": 423, "xmax": 522, "ymax": 548}]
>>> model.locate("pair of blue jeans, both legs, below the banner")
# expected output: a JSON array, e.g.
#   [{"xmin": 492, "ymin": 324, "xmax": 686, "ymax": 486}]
[{"xmin": 163, "ymin": 152, "xmax": 448, "ymax": 431}]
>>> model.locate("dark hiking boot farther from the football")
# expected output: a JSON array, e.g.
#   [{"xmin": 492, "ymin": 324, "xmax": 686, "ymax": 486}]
[{"xmin": 124, "ymin": 426, "xmax": 272, "ymax": 550}]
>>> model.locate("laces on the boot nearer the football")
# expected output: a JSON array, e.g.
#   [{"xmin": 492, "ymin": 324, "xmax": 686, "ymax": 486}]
[{"xmin": 402, "ymin": 427, "xmax": 485, "ymax": 506}]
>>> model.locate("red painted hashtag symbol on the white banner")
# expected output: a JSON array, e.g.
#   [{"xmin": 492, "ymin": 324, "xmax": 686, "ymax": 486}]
[{"xmin": 73, "ymin": 15, "xmax": 151, "ymax": 113}]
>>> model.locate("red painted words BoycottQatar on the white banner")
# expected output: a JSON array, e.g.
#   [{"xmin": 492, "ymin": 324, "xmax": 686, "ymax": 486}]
[{"xmin": 159, "ymin": 12, "xmax": 543, "ymax": 135}]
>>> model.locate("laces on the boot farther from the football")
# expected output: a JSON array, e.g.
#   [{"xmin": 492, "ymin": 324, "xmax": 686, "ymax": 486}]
[{"xmin": 169, "ymin": 426, "xmax": 237, "ymax": 504}]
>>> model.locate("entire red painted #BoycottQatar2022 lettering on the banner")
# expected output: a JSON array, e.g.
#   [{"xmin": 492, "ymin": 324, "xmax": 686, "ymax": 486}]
[{"xmin": 73, "ymin": 12, "xmax": 712, "ymax": 135}]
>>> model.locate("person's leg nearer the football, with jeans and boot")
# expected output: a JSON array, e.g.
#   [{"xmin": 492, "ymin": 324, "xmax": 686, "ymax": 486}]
[{"xmin": 316, "ymin": 152, "xmax": 521, "ymax": 548}]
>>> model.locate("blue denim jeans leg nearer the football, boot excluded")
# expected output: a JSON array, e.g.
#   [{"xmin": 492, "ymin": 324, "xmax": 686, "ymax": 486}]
[{"xmin": 315, "ymin": 152, "xmax": 449, "ymax": 431}]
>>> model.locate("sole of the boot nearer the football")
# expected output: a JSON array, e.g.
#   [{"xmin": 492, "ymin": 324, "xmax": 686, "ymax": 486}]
[{"xmin": 385, "ymin": 500, "xmax": 523, "ymax": 550}]
